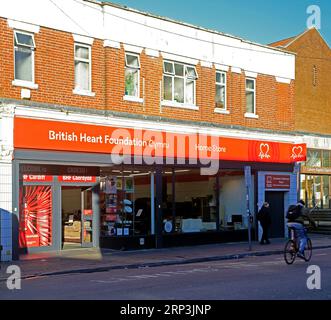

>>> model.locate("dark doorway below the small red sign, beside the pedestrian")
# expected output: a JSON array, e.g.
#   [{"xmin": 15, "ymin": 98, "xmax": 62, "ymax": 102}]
[{"xmin": 265, "ymin": 192, "xmax": 285, "ymax": 238}]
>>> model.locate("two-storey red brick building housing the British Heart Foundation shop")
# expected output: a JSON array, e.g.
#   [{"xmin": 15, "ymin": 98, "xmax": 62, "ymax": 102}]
[{"xmin": 0, "ymin": 0, "xmax": 306, "ymax": 260}]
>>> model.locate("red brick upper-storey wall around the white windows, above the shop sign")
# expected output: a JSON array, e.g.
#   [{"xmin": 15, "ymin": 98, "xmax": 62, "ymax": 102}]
[{"xmin": 0, "ymin": 19, "xmax": 294, "ymax": 131}]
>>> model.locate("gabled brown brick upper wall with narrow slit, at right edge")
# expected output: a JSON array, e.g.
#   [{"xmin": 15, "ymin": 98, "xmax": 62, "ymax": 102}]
[{"xmin": 286, "ymin": 29, "xmax": 331, "ymax": 134}]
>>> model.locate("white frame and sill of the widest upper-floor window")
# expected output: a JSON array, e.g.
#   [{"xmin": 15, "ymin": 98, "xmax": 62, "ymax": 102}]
[{"xmin": 162, "ymin": 60, "xmax": 199, "ymax": 110}]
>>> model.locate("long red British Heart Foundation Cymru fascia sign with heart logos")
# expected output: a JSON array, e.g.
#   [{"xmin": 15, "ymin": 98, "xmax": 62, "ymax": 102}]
[{"xmin": 14, "ymin": 117, "xmax": 307, "ymax": 164}]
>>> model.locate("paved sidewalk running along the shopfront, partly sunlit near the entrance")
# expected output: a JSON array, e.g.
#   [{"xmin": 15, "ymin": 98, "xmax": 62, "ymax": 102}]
[{"xmin": 0, "ymin": 234, "xmax": 331, "ymax": 282}]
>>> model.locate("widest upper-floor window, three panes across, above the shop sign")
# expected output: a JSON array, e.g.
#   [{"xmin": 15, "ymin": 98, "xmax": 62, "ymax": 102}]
[{"xmin": 163, "ymin": 61, "xmax": 198, "ymax": 105}]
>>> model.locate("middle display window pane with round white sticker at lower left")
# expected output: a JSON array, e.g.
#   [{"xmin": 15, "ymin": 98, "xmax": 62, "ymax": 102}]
[{"xmin": 162, "ymin": 169, "xmax": 218, "ymax": 233}]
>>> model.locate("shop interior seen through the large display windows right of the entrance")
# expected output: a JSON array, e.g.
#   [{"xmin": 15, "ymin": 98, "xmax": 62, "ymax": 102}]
[{"xmin": 100, "ymin": 166, "xmax": 253, "ymax": 237}]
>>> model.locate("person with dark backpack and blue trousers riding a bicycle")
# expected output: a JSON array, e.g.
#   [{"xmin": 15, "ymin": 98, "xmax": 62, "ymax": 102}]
[{"xmin": 287, "ymin": 200, "xmax": 316, "ymax": 259}]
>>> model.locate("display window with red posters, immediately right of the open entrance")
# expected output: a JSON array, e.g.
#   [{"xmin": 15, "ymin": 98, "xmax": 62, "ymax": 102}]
[{"xmin": 100, "ymin": 166, "xmax": 152, "ymax": 237}]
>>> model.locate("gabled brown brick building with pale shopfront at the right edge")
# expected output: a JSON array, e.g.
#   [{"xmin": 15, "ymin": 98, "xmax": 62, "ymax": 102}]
[{"xmin": 271, "ymin": 28, "xmax": 331, "ymax": 210}]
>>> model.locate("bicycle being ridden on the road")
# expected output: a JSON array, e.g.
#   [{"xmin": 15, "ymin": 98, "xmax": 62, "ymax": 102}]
[{"xmin": 284, "ymin": 227, "xmax": 313, "ymax": 264}]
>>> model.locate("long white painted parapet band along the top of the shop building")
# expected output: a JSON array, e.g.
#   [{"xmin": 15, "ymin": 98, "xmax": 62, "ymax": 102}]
[{"xmin": 0, "ymin": 0, "xmax": 295, "ymax": 80}]
